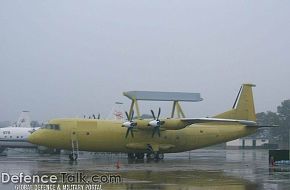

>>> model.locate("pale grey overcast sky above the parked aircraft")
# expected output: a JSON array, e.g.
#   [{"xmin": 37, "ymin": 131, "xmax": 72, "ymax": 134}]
[{"xmin": 0, "ymin": 0, "xmax": 290, "ymax": 121}]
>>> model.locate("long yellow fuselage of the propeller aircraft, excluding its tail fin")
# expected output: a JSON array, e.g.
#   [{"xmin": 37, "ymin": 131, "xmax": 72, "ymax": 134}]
[{"xmin": 29, "ymin": 119, "xmax": 256, "ymax": 152}]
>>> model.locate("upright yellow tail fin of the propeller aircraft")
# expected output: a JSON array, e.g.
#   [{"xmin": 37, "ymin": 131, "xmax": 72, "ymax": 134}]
[{"xmin": 214, "ymin": 84, "xmax": 256, "ymax": 121}]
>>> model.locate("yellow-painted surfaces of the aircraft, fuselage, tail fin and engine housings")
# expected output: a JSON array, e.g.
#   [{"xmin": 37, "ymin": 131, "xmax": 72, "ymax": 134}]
[{"xmin": 28, "ymin": 84, "xmax": 257, "ymax": 153}]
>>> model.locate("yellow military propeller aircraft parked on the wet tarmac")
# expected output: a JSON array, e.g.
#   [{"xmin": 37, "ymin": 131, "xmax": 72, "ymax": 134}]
[{"xmin": 28, "ymin": 84, "xmax": 274, "ymax": 160}]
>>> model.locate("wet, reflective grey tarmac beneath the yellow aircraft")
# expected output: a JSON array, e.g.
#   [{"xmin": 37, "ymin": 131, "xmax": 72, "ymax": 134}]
[{"xmin": 0, "ymin": 149, "xmax": 290, "ymax": 190}]
